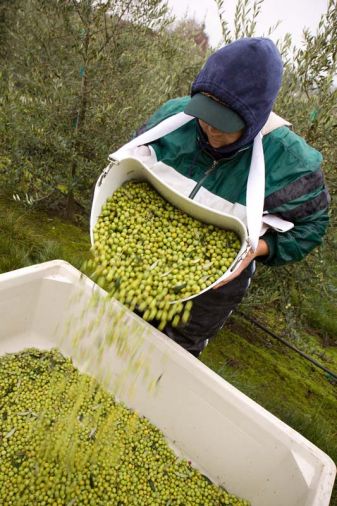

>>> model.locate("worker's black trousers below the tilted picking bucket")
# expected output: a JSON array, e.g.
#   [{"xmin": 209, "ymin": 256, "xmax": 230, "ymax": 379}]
[{"xmin": 164, "ymin": 262, "xmax": 255, "ymax": 357}]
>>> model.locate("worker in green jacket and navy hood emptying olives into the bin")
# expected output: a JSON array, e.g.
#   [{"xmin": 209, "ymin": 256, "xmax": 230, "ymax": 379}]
[{"xmin": 122, "ymin": 37, "xmax": 329, "ymax": 357}]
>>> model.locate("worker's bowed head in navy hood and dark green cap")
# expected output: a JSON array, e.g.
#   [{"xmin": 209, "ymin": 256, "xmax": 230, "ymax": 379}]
[{"xmin": 185, "ymin": 37, "xmax": 283, "ymax": 152}]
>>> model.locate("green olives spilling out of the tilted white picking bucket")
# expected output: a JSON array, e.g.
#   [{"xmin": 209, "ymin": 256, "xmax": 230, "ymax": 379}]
[{"xmin": 87, "ymin": 181, "xmax": 240, "ymax": 329}]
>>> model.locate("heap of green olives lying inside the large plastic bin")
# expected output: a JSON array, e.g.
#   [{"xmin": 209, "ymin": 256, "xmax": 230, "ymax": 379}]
[{"xmin": 0, "ymin": 349, "xmax": 249, "ymax": 506}]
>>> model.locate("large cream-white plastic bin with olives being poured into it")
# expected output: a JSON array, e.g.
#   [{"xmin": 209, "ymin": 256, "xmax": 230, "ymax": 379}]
[{"xmin": 0, "ymin": 261, "xmax": 336, "ymax": 506}]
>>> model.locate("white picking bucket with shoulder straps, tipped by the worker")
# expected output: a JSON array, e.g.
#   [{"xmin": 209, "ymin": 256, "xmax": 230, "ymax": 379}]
[{"xmin": 90, "ymin": 112, "xmax": 293, "ymax": 298}]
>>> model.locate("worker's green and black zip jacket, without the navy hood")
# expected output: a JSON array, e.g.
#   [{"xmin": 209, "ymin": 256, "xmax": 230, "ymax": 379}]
[{"xmin": 145, "ymin": 97, "xmax": 329, "ymax": 265}]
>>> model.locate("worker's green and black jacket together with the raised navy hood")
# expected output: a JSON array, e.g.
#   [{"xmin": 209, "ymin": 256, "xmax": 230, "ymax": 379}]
[{"xmin": 135, "ymin": 38, "xmax": 329, "ymax": 265}]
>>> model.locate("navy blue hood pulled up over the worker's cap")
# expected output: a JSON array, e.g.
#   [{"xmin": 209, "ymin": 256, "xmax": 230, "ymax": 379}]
[{"xmin": 191, "ymin": 37, "xmax": 283, "ymax": 154}]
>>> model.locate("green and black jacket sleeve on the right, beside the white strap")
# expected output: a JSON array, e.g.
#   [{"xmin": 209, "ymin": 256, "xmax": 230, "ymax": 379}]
[{"xmin": 259, "ymin": 127, "xmax": 330, "ymax": 266}]
